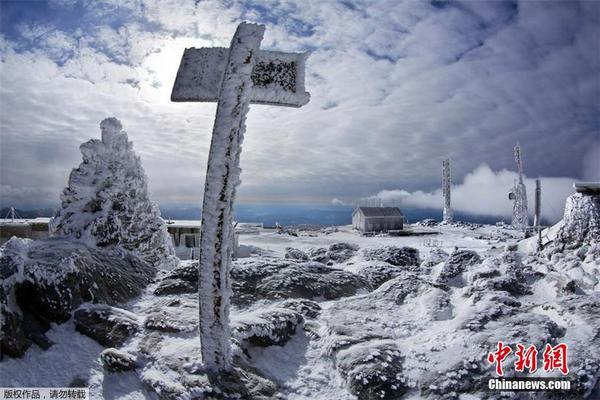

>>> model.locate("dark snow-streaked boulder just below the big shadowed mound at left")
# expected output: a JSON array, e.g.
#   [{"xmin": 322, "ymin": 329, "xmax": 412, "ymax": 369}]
[{"xmin": 73, "ymin": 304, "xmax": 140, "ymax": 347}]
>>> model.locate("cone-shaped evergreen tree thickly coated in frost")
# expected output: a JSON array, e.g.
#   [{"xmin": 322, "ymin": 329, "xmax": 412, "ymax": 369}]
[{"xmin": 50, "ymin": 118, "xmax": 176, "ymax": 265}]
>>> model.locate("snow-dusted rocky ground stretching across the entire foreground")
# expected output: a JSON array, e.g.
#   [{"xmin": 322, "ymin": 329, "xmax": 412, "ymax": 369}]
[{"xmin": 0, "ymin": 189, "xmax": 600, "ymax": 400}]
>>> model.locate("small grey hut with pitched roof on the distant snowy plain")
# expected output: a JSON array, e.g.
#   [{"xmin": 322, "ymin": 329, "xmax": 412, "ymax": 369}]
[{"xmin": 352, "ymin": 206, "xmax": 404, "ymax": 233}]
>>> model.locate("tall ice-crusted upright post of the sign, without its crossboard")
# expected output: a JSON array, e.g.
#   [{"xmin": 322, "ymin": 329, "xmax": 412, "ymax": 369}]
[{"xmin": 199, "ymin": 23, "xmax": 265, "ymax": 371}]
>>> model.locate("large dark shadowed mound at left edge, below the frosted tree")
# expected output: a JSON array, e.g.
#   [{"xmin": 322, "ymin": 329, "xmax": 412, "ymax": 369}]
[{"xmin": 0, "ymin": 238, "xmax": 156, "ymax": 357}]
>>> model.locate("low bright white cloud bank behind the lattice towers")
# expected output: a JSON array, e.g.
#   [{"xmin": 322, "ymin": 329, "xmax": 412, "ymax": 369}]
[{"xmin": 367, "ymin": 164, "xmax": 576, "ymax": 223}]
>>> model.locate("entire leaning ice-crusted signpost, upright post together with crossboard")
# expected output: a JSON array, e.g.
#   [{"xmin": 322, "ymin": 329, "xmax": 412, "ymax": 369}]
[{"xmin": 171, "ymin": 23, "xmax": 310, "ymax": 371}]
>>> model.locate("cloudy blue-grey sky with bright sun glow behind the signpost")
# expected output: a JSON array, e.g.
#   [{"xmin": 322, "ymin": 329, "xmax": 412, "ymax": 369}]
[{"xmin": 0, "ymin": 0, "xmax": 600, "ymax": 220}]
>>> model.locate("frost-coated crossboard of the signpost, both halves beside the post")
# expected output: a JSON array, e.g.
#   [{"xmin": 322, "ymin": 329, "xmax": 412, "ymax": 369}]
[{"xmin": 171, "ymin": 47, "xmax": 310, "ymax": 107}]
